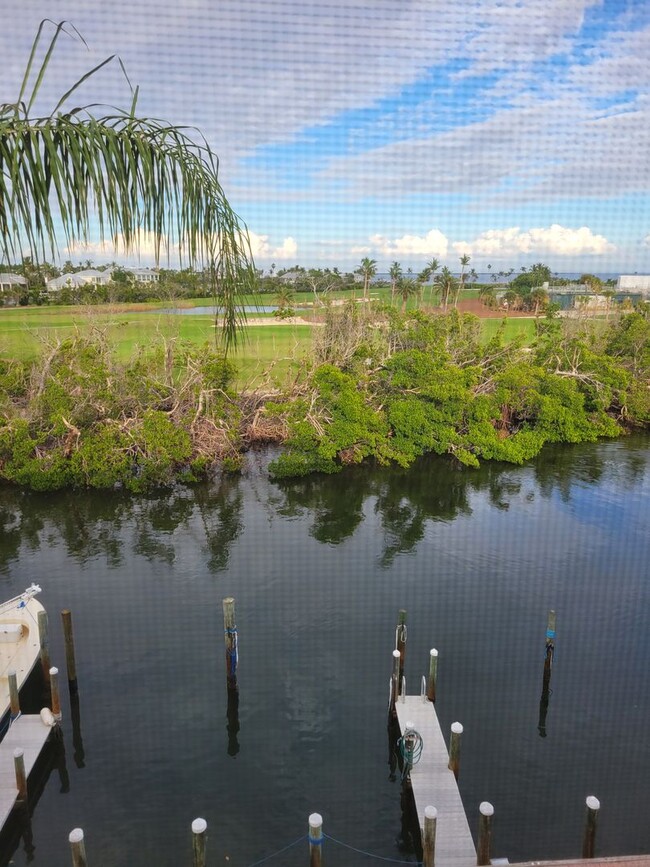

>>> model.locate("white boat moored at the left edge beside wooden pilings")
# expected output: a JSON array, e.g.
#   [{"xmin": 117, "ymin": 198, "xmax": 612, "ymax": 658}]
[{"xmin": 0, "ymin": 584, "xmax": 45, "ymax": 720}]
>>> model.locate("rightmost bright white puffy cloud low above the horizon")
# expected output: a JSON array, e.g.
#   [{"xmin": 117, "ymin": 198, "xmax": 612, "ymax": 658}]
[{"xmin": 453, "ymin": 223, "xmax": 616, "ymax": 259}]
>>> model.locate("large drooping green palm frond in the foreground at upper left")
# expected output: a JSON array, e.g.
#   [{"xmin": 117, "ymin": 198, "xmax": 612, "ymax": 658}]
[{"xmin": 0, "ymin": 21, "xmax": 255, "ymax": 349}]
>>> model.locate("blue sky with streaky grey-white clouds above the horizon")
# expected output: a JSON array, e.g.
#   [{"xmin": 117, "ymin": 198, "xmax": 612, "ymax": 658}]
[{"xmin": 0, "ymin": 0, "xmax": 650, "ymax": 274}]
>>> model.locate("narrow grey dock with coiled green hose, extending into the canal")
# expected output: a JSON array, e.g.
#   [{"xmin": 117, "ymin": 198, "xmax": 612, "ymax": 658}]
[{"xmin": 396, "ymin": 695, "xmax": 476, "ymax": 867}]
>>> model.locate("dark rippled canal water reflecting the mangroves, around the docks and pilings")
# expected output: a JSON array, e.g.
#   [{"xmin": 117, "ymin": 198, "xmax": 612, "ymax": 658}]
[{"xmin": 0, "ymin": 437, "xmax": 650, "ymax": 867}]
